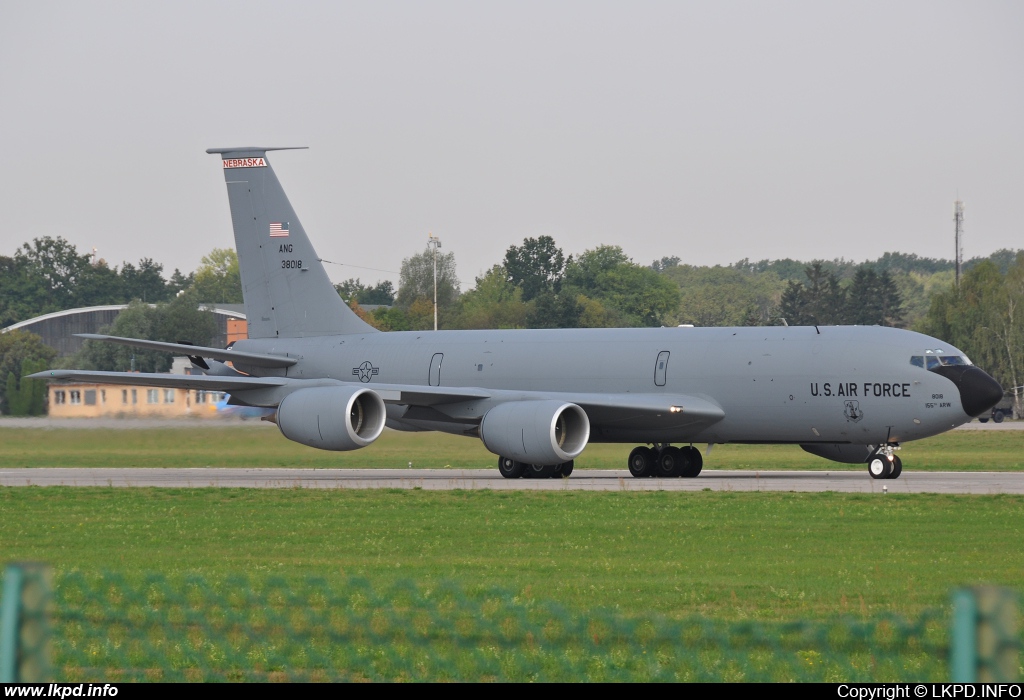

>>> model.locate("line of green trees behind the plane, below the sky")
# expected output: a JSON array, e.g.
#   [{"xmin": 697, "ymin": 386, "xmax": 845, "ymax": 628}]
[{"xmin": 0, "ymin": 235, "xmax": 1024, "ymax": 410}]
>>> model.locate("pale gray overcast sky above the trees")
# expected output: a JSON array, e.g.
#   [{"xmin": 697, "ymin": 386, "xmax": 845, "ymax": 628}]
[{"xmin": 0, "ymin": 0, "xmax": 1024, "ymax": 289}]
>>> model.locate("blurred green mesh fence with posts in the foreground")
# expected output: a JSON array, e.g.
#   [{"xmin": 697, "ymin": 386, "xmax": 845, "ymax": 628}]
[{"xmin": 0, "ymin": 565, "xmax": 1020, "ymax": 682}]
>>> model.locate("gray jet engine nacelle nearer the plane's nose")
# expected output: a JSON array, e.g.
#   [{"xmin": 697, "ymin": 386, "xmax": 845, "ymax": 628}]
[{"xmin": 480, "ymin": 400, "xmax": 590, "ymax": 465}]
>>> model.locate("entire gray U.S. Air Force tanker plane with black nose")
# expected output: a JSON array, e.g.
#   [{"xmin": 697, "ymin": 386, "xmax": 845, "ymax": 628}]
[{"xmin": 35, "ymin": 147, "xmax": 1002, "ymax": 479}]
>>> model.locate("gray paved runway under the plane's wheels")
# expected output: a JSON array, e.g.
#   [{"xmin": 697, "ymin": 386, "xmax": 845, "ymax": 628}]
[{"xmin": 0, "ymin": 468, "xmax": 1024, "ymax": 494}]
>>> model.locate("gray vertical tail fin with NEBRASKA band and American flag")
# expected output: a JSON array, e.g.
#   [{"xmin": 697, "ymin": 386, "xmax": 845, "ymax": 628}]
[{"xmin": 206, "ymin": 146, "xmax": 375, "ymax": 338}]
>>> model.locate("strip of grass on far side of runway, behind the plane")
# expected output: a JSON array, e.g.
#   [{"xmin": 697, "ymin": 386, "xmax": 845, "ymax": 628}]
[{"xmin": 0, "ymin": 425, "xmax": 1024, "ymax": 471}]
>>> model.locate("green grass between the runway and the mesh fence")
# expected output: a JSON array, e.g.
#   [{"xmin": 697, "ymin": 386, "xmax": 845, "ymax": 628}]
[{"xmin": 0, "ymin": 488, "xmax": 1024, "ymax": 619}]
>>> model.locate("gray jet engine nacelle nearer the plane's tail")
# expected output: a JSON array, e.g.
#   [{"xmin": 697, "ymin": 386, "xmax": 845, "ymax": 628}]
[{"xmin": 278, "ymin": 387, "xmax": 385, "ymax": 450}]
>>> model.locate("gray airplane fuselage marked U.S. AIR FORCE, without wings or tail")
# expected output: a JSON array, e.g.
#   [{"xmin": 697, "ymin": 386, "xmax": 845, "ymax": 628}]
[{"xmin": 234, "ymin": 326, "xmax": 971, "ymax": 444}]
